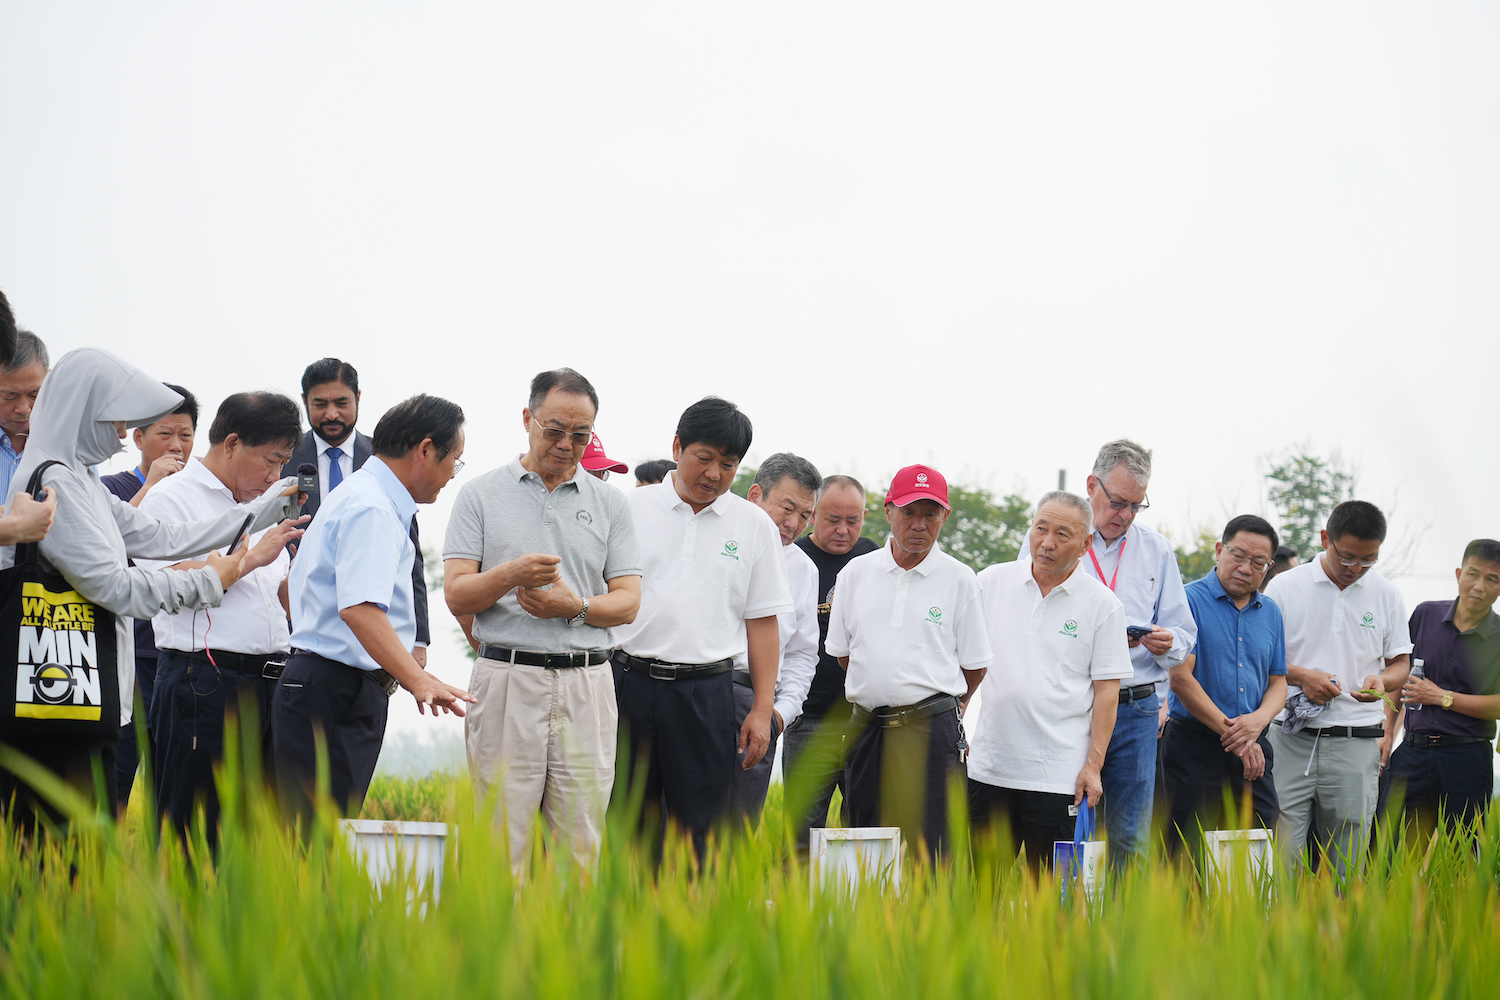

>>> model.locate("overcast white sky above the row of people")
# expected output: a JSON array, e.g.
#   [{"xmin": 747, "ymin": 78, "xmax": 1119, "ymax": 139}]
[{"xmin": 0, "ymin": 0, "xmax": 1500, "ymax": 743}]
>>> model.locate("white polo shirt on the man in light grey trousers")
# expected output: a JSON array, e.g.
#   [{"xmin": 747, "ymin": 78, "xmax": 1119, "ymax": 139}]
[{"xmin": 1266, "ymin": 553, "xmax": 1412, "ymax": 729}]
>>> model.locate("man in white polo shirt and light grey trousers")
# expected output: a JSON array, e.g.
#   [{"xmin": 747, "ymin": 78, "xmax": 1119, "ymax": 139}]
[{"xmin": 1266, "ymin": 501, "xmax": 1412, "ymax": 873}]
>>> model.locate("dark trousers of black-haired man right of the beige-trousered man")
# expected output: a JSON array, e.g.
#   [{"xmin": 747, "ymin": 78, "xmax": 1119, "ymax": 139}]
[{"xmin": 614, "ymin": 660, "xmax": 740, "ymax": 859}]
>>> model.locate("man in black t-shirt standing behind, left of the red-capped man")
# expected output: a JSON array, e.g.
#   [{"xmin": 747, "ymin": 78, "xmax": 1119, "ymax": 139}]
[{"xmin": 782, "ymin": 475, "xmax": 879, "ymax": 849}]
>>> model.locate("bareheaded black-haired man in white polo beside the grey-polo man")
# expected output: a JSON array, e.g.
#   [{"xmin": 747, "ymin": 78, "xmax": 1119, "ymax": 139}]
[{"xmin": 614, "ymin": 396, "xmax": 795, "ymax": 859}]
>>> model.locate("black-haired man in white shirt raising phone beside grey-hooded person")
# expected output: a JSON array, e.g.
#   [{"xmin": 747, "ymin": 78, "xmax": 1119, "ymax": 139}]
[{"xmin": 138, "ymin": 393, "xmax": 306, "ymax": 844}]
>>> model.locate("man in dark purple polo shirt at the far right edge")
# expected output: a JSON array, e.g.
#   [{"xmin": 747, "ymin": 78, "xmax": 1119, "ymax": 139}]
[{"xmin": 1382, "ymin": 538, "xmax": 1500, "ymax": 829}]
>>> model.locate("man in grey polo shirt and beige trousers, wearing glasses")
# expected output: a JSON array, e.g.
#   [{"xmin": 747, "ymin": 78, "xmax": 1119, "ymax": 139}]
[{"xmin": 443, "ymin": 369, "xmax": 641, "ymax": 867}]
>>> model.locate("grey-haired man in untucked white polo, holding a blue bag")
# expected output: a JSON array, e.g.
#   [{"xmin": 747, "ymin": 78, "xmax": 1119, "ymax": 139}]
[{"xmin": 969, "ymin": 490, "xmax": 1134, "ymax": 871}]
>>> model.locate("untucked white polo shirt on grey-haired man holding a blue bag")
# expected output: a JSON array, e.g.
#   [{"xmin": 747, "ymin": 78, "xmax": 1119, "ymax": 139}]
[{"xmin": 969, "ymin": 559, "xmax": 1136, "ymax": 795}]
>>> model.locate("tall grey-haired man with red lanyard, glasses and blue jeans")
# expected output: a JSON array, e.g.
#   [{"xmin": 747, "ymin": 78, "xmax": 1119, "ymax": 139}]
[{"xmin": 1022, "ymin": 439, "xmax": 1199, "ymax": 867}]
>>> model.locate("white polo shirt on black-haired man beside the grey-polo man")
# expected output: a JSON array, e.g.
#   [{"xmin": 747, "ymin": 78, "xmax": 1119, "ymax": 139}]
[{"xmin": 611, "ymin": 475, "xmax": 794, "ymax": 663}]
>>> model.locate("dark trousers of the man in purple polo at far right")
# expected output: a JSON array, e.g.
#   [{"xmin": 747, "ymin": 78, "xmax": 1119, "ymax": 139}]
[{"xmin": 1376, "ymin": 741, "xmax": 1494, "ymax": 829}]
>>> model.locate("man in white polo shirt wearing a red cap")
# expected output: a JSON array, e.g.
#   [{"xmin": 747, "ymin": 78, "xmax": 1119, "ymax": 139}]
[{"xmin": 824, "ymin": 465, "xmax": 990, "ymax": 858}]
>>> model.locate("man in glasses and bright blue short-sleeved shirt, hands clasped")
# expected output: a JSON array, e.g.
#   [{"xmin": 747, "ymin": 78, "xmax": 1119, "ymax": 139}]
[{"xmin": 1163, "ymin": 514, "xmax": 1287, "ymax": 853}]
